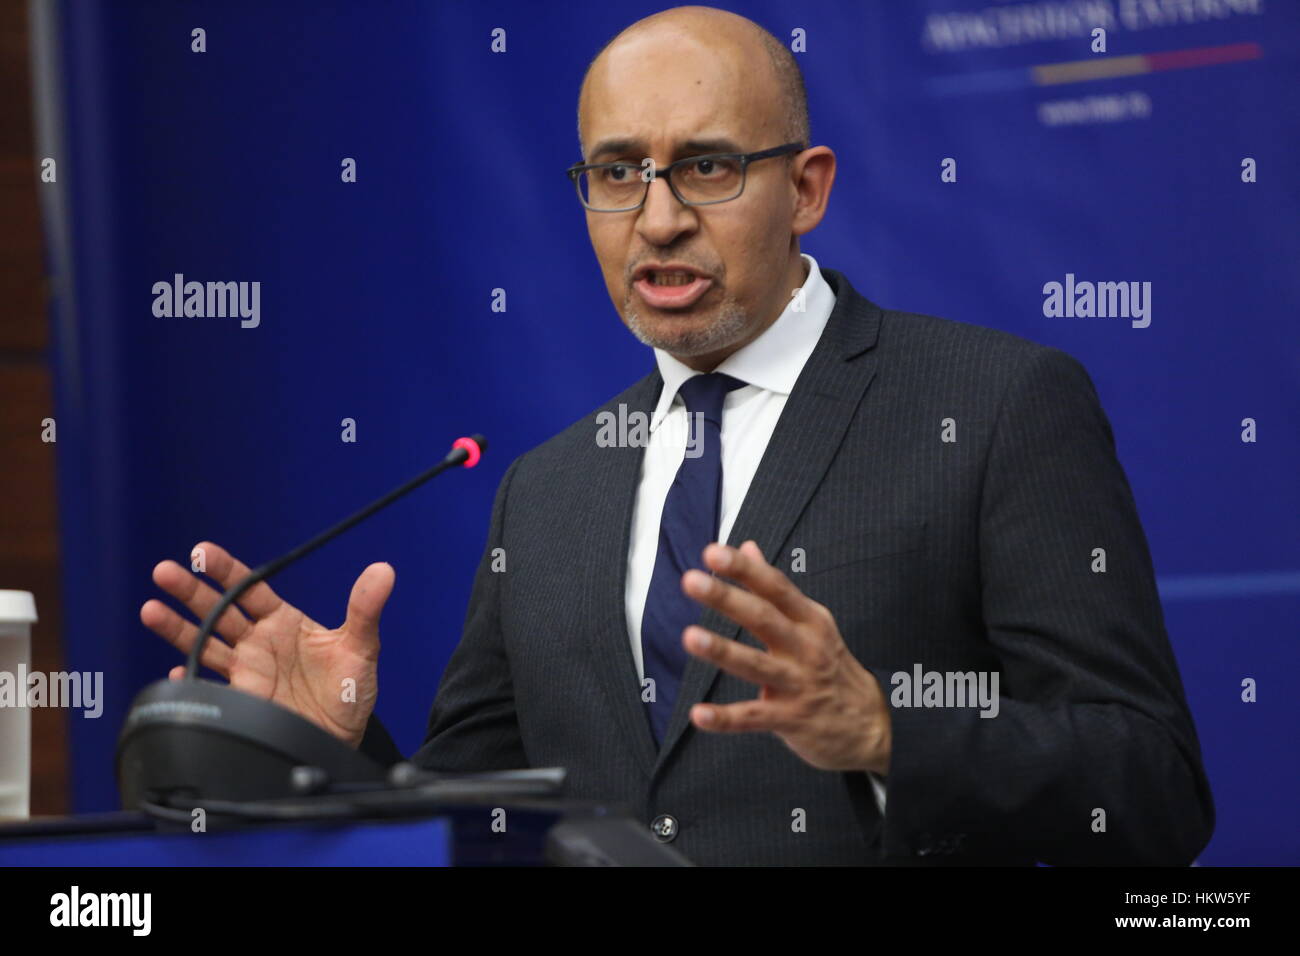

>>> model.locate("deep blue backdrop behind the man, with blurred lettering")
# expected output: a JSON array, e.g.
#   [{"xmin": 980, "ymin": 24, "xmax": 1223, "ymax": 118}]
[{"xmin": 36, "ymin": 0, "xmax": 1300, "ymax": 864}]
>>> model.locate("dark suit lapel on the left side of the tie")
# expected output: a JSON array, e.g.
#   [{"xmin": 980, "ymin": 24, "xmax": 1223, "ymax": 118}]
[{"xmin": 587, "ymin": 369, "xmax": 663, "ymax": 777}]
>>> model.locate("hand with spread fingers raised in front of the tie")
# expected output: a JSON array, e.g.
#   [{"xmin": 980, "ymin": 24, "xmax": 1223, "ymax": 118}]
[{"xmin": 681, "ymin": 541, "xmax": 891, "ymax": 777}]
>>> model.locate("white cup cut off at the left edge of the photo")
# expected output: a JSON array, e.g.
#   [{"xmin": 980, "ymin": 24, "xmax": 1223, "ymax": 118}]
[{"xmin": 0, "ymin": 591, "xmax": 36, "ymax": 818}]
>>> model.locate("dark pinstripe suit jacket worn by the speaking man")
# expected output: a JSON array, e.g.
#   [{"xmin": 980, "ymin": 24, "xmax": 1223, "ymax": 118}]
[{"xmin": 365, "ymin": 269, "xmax": 1214, "ymax": 865}]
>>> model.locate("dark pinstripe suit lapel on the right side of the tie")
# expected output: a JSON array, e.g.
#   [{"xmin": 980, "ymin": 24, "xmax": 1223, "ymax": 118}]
[{"xmin": 650, "ymin": 268, "xmax": 880, "ymax": 773}]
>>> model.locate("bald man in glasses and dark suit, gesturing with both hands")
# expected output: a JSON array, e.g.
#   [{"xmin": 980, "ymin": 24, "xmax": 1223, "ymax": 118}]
[{"xmin": 142, "ymin": 7, "xmax": 1213, "ymax": 864}]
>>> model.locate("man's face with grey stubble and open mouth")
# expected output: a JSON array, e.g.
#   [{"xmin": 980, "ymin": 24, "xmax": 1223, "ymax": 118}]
[{"xmin": 581, "ymin": 33, "xmax": 796, "ymax": 358}]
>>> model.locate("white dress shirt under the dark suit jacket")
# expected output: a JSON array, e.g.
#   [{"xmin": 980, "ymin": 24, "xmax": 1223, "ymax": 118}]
[{"xmin": 624, "ymin": 252, "xmax": 885, "ymax": 814}]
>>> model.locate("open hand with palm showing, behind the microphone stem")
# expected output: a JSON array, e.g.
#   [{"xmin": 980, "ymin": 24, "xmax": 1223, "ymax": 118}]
[{"xmin": 140, "ymin": 541, "xmax": 397, "ymax": 747}]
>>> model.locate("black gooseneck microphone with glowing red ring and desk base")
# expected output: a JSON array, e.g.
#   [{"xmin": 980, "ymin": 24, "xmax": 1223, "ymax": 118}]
[{"xmin": 117, "ymin": 434, "xmax": 488, "ymax": 808}]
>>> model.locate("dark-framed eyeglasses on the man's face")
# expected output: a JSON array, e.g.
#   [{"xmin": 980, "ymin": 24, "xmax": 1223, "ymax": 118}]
[{"xmin": 566, "ymin": 143, "xmax": 805, "ymax": 212}]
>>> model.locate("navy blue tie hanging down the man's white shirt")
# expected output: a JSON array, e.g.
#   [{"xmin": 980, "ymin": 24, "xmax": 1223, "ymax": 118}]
[{"xmin": 641, "ymin": 372, "xmax": 745, "ymax": 743}]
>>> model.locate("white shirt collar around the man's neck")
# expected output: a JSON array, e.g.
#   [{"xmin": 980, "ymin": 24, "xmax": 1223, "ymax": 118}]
[{"xmin": 650, "ymin": 252, "xmax": 835, "ymax": 432}]
